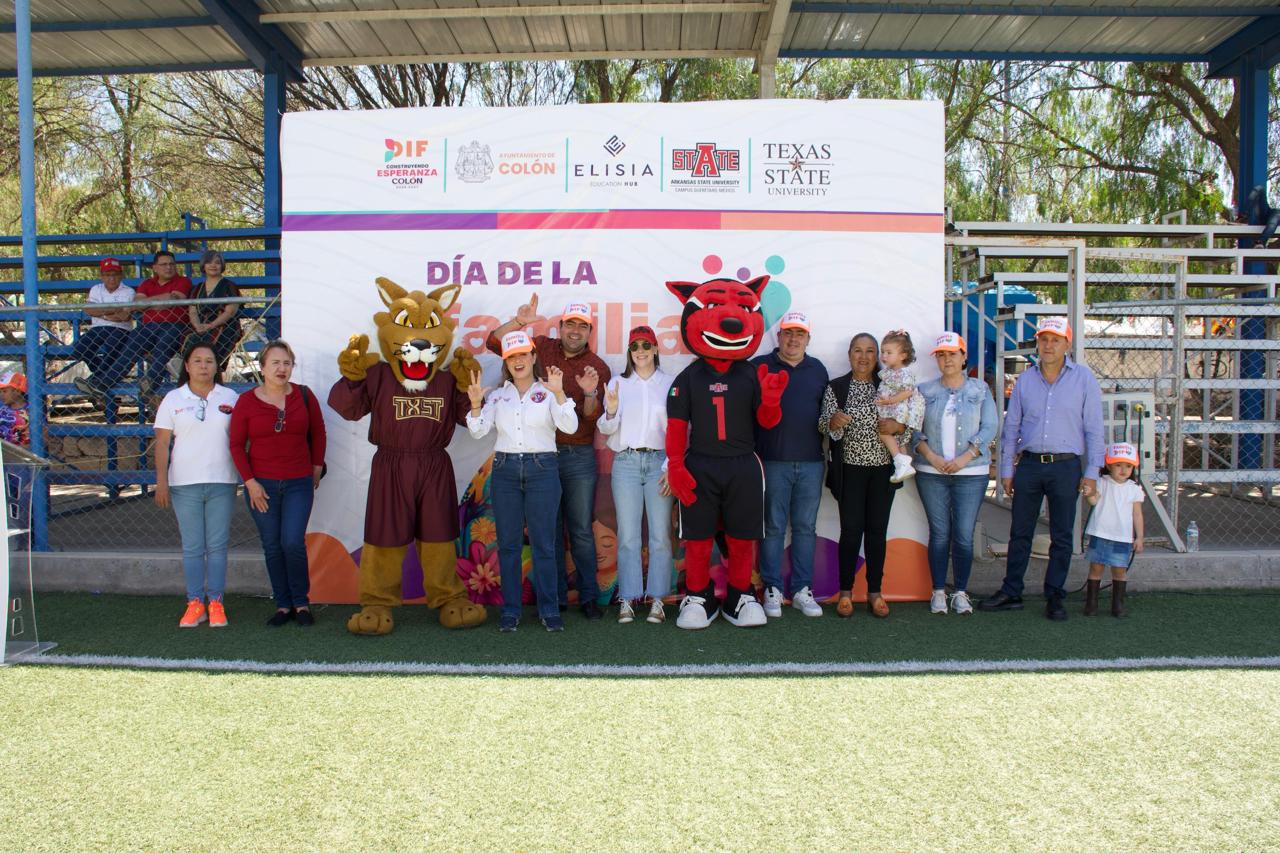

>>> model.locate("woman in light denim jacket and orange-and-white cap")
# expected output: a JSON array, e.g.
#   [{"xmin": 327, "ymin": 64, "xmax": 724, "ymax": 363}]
[{"xmin": 914, "ymin": 332, "xmax": 997, "ymax": 615}]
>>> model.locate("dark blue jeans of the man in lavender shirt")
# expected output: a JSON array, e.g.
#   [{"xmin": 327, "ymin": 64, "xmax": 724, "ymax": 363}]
[{"xmin": 1001, "ymin": 453, "xmax": 1080, "ymax": 598}]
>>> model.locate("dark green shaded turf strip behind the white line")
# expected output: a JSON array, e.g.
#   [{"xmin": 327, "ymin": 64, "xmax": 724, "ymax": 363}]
[{"xmin": 17, "ymin": 592, "xmax": 1280, "ymax": 665}]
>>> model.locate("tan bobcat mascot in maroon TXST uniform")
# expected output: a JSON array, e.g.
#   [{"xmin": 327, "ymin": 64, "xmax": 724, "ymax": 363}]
[{"xmin": 329, "ymin": 278, "xmax": 485, "ymax": 634}]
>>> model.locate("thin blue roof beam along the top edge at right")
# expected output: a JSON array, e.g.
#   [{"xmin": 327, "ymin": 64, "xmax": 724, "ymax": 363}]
[{"xmin": 791, "ymin": 1, "xmax": 1280, "ymax": 18}]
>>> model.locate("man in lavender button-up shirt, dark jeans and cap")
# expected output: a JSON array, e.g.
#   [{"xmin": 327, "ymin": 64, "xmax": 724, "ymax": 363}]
[{"xmin": 978, "ymin": 316, "xmax": 1103, "ymax": 621}]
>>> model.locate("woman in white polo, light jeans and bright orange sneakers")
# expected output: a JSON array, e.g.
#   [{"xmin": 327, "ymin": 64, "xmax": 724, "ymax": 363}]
[{"xmin": 155, "ymin": 343, "xmax": 237, "ymax": 628}]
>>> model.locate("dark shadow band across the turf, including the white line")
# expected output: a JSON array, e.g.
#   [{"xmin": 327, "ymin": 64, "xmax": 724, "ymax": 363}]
[{"xmin": 15, "ymin": 592, "xmax": 1280, "ymax": 678}]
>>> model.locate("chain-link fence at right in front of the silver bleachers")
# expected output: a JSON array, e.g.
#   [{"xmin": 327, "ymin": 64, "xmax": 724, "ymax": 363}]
[{"xmin": 1084, "ymin": 250, "xmax": 1280, "ymax": 549}]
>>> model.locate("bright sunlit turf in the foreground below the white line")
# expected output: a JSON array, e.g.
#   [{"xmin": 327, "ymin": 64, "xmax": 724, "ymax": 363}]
[{"xmin": 0, "ymin": 666, "xmax": 1280, "ymax": 852}]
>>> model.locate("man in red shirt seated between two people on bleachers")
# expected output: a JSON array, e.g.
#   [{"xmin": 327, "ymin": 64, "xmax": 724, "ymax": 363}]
[{"xmin": 93, "ymin": 248, "xmax": 191, "ymax": 394}]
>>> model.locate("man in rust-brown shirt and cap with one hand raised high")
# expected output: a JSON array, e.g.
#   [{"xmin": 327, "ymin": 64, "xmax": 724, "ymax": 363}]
[{"xmin": 488, "ymin": 293, "xmax": 609, "ymax": 621}]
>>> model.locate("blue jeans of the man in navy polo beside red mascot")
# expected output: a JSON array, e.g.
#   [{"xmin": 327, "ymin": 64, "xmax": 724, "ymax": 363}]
[{"xmin": 760, "ymin": 460, "xmax": 827, "ymax": 594}]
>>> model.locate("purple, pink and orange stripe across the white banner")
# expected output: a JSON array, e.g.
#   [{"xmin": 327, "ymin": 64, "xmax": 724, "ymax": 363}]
[{"xmin": 284, "ymin": 210, "xmax": 945, "ymax": 234}]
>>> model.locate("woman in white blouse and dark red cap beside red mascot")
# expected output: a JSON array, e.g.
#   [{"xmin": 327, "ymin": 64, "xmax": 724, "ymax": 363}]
[{"xmin": 595, "ymin": 325, "xmax": 675, "ymax": 624}]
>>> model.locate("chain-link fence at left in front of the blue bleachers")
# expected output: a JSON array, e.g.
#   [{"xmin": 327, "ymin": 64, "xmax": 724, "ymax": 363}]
[{"xmin": 0, "ymin": 295, "xmax": 279, "ymax": 552}]
